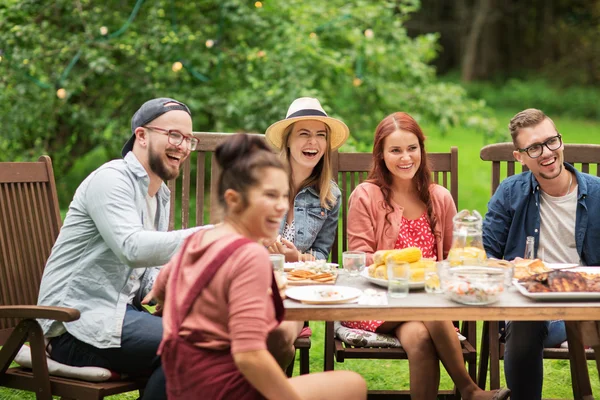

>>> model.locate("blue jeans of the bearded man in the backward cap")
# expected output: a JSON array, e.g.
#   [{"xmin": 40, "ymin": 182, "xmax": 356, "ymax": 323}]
[{"xmin": 50, "ymin": 305, "xmax": 167, "ymax": 400}]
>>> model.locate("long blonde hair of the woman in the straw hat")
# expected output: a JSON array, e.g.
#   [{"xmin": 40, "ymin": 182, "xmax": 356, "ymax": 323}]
[{"xmin": 279, "ymin": 124, "xmax": 336, "ymax": 210}]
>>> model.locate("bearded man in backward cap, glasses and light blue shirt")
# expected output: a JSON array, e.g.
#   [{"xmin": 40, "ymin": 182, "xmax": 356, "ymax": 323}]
[{"xmin": 38, "ymin": 98, "xmax": 203, "ymax": 399}]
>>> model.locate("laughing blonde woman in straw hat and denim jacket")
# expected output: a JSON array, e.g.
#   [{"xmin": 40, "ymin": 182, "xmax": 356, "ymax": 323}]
[{"xmin": 265, "ymin": 97, "xmax": 349, "ymax": 262}]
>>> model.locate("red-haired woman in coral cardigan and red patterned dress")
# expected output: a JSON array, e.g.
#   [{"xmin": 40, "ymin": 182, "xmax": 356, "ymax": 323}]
[{"xmin": 342, "ymin": 112, "xmax": 510, "ymax": 400}]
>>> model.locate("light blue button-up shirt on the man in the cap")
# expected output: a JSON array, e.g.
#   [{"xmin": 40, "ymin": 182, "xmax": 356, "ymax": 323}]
[{"xmin": 38, "ymin": 152, "xmax": 198, "ymax": 348}]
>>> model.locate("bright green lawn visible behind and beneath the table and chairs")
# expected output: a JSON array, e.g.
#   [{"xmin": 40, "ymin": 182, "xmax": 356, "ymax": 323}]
[{"xmin": 0, "ymin": 109, "xmax": 600, "ymax": 400}]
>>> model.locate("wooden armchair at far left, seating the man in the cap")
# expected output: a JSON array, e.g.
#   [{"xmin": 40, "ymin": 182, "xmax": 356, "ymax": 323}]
[{"xmin": 0, "ymin": 156, "xmax": 143, "ymax": 399}]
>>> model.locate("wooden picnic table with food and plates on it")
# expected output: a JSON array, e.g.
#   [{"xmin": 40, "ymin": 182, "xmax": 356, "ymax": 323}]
[{"xmin": 284, "ymin": 275, "xmax": 600, "ymax": 400}]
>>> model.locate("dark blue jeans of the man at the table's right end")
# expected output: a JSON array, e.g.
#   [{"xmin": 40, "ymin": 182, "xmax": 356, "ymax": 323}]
[{"xmin": 504, "ymin": 321, "xmax": 567, "ymax": 400}]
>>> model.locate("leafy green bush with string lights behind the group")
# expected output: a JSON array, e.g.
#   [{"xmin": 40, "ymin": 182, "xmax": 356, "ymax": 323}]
[{"xmin": 0, "ymin": 0, "xmax": 496, "ymax": 206}]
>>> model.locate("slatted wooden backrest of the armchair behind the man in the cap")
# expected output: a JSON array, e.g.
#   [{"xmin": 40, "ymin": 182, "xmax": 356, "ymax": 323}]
[{"xmin": 0, "ymin": 156, "xmax": 61, "ymax": 336}]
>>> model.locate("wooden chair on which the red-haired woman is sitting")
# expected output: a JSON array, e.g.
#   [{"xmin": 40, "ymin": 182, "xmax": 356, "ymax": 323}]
[{"xmin": 324, "ymin": 147, "xmax": 477, "ymax": 398}]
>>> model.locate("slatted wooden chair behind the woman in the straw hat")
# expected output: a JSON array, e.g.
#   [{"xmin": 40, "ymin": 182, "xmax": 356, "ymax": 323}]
[{"xmin": 168, "ymin": 132, "xmax": 311, "ymax": 376}]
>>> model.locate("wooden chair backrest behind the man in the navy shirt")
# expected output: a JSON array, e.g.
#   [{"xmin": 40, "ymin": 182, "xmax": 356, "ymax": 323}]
[{"xmin": 479, "ymin": 142, "xmax": 600, "ymax": 194}]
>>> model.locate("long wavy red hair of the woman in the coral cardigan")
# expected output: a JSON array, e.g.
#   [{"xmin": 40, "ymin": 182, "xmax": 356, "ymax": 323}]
[{"xmin": 367, "ymin": 112, "xmax": 437, "ymax": 235}]
